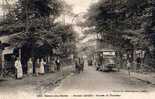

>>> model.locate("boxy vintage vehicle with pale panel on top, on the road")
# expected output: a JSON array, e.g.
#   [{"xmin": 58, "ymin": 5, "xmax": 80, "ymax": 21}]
[{"xmin": 96, "ymin": 50, "xmax": 116, "ymax": 71}]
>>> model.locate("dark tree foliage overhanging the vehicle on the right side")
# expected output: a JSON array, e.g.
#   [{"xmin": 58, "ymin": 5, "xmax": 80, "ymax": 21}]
[{"xmin": 87, "ymin": 0, "xmax": 151, "ymax": 48}]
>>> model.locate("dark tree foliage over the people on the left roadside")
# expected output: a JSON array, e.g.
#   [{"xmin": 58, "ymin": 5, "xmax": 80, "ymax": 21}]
[{"xmin": 0, "ymin": 0, "xmax": 75, "ymax": 56}]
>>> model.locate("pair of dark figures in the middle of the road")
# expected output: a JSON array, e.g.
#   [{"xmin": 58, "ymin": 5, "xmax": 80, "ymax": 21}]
[{"xmin": 75, "ymin": 57, "xmax": 84, "ymax": 73}]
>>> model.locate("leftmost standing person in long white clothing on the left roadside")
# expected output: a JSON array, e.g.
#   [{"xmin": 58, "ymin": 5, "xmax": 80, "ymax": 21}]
[{"xmin": 15, "ymin": 57, "xmax": 23, "ymax": 79}]
